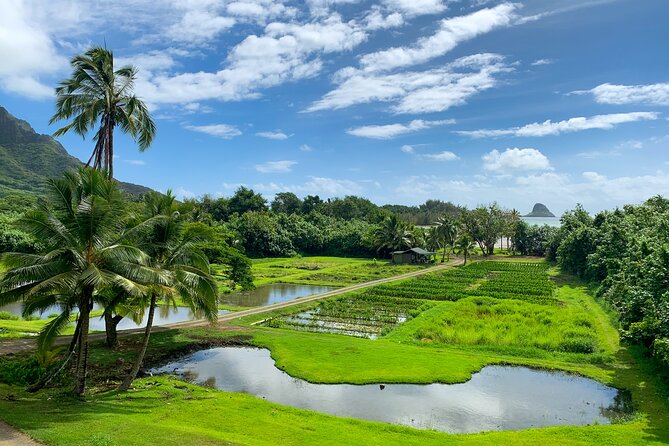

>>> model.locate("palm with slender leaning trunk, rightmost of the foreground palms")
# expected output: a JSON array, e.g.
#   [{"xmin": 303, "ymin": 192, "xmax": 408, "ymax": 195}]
[{"xmin": 119, "ymin": 191, "xmax": 218, "ymax": 391}]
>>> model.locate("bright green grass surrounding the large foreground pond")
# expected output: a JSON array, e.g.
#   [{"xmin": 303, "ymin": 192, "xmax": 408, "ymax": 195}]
[{"xmin": 0, "ymin": 262, "xmax": 669, "ymax": 445}]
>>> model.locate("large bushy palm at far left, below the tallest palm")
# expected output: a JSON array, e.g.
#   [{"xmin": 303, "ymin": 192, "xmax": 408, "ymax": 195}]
[{"xmin": 0, "ymin": 167, "xmax": 165, "ymax": 395}]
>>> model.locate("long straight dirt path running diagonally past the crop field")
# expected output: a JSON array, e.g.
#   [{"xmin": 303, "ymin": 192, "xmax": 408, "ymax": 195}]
[{"xmin": 0, "ymin": 259, "xmax": 462, "ymax": 356}]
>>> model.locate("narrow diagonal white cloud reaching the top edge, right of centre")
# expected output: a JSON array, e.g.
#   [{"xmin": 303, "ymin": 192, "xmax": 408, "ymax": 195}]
[{"xmin": 360, "ymin": 1, "xmax": 517, "ymax": 71}]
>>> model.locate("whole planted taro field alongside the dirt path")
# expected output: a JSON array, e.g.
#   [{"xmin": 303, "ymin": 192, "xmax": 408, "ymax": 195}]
[{"xmin": 264, "ymin": 261, "xmax": 557, "ymax": 339}]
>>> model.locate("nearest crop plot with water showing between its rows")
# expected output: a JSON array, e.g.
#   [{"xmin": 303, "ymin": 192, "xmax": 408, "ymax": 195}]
[{"xmin": 265, "ymin": 293, "xmax": 433, "ymax": 339}]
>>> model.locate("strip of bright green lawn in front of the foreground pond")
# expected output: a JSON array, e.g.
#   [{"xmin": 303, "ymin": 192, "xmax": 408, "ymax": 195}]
[{"xmin": 0, "ymin": 377, "xmax": 666, "ymax": 446}]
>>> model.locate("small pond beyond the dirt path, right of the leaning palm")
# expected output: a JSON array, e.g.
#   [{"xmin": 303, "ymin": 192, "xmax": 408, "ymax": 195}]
[{"xmin": 222, "ymin": 283, "xmax": 336, "ymax": 307}]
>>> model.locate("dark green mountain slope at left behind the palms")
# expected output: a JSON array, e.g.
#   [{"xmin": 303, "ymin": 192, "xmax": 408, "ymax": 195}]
[{"xmin": 0, "ymin": 106, "xmax": 151, "ymax": 195}]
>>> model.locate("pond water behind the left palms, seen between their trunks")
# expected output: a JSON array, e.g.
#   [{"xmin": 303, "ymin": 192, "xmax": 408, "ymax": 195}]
[{"xmin": 0, "ymin": 303, "xmax": 228, "ymax": 331}]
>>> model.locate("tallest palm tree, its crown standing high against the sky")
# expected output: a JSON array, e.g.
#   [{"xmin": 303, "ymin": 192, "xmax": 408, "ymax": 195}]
[{"xmin": 49, "ymin": 47, "xmax": 156, "ymax": 178}]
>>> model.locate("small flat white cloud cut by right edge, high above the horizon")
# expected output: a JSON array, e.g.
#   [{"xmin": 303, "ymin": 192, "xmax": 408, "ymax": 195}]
[{"xmin": 574, "ymin": 83, "xmax": 669, "ymax": 105}]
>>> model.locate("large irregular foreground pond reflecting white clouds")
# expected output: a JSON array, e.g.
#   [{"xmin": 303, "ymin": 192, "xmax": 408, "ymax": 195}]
[{"xmin": 152, "ymin": 347, "xmax": 631, "ymax": 433}]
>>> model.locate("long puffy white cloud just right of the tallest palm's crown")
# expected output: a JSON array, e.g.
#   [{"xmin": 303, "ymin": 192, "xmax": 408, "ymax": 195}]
[{"xmin": 137, "ymin": 14, "xmax": 367, "ymax": 104}]
